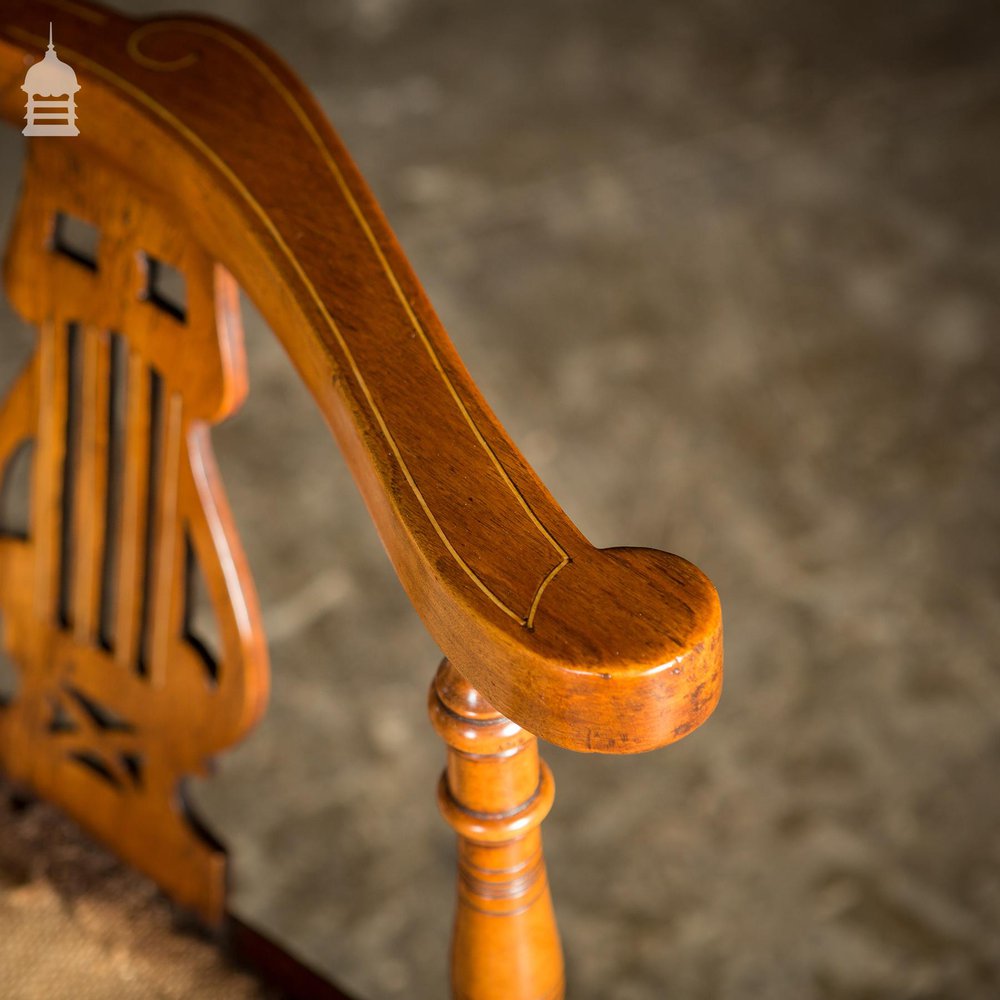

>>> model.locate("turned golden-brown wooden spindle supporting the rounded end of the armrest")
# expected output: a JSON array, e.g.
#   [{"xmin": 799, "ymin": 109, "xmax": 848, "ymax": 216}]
[{"xmin": 430, "ymin": 660, "xmax": 564, "ymax": 1000}]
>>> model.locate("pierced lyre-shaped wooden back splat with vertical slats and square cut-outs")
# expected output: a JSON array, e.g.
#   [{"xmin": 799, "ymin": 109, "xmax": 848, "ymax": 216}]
[{"xmin": 0, "ymin": 142, "xmax": 267, "ymax": 921}]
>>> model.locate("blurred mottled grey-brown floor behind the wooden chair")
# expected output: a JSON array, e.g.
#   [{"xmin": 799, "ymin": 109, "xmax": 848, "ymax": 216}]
[{"xmin": 0, "ymin": 0, "xmax": 1000, "ymax": 1000}]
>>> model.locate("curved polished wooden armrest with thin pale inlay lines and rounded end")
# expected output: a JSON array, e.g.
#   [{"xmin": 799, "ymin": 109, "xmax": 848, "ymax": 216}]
[{"xmin": 0, "ymin": 0, "xmax": 722, "ymax": 753}]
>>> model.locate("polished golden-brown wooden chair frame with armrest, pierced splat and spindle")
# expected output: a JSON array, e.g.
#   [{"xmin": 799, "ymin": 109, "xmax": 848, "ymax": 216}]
[{"xmin": 0, "ymin": 0, "xmax": 722, "ymax": 1000}]
